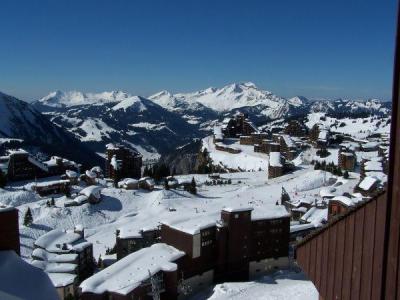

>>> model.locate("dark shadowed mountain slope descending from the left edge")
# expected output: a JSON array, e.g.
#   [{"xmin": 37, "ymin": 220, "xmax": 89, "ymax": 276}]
[{"xmin": 0, "ymin": 92, "xmax": 100, "ymax": 164}]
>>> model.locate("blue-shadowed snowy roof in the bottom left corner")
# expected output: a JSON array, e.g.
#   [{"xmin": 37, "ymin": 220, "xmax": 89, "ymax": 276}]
[{"xmin": 0, "ymin": 251, "xmax": 59, "ymax": 300}]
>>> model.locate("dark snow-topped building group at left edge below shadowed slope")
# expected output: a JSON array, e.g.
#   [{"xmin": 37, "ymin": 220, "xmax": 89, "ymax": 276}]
[{"xmin": 0, "ymin": 149, "xmax": 81, "ymax": 181}]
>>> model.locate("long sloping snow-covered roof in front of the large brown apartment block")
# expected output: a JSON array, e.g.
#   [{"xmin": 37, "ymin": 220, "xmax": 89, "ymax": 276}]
[{"xmin": 80, "ymin": 243, "xmax": 185, "ymax": 295}]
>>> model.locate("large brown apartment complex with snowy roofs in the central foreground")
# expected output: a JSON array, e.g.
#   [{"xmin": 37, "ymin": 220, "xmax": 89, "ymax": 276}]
[{"xmin": 80, "ymin": 205, "xmax": 290, "ymax": 299}]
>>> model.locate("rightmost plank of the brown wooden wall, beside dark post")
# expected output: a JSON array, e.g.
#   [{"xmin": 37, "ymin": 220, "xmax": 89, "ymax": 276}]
[{"xmin": 371, "ymin": 195, "xmax": 386, "ymax": 299}]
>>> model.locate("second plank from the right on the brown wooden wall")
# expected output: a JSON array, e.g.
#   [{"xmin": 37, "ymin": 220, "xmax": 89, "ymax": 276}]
[{"xmin": 360, "ymin": 201, "xmax": 376, "ymax": 299}]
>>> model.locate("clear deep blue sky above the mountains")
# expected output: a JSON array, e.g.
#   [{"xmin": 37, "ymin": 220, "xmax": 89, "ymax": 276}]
[{"xmin": 0, "ymin": 0, "xmax": 397, "ymax": 100}]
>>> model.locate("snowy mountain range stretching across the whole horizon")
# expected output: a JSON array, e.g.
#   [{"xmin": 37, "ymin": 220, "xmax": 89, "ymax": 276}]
[{"xmin": 0, "ymin": 82, "xmax": 391, "ymax": 164}]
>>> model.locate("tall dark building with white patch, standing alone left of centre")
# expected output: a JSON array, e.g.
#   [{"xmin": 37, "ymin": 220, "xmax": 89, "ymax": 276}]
[{"xmin": 105, "ymin": 144, "xmax": 142, "ymax": 180}]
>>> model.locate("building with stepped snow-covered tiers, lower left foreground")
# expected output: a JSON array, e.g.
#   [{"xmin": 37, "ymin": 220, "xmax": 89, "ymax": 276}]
[{"xmin": 32, "ymin": 226, "xmax": 94, "ymax": 299}]
